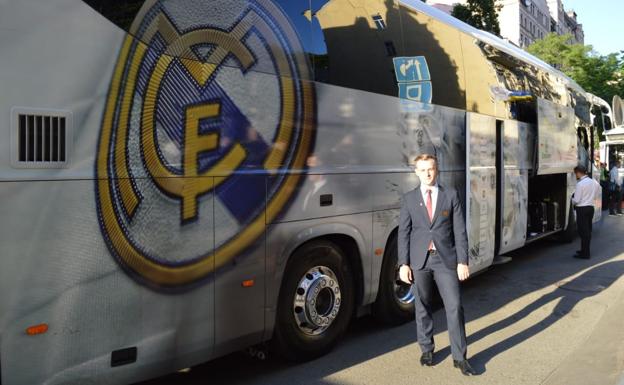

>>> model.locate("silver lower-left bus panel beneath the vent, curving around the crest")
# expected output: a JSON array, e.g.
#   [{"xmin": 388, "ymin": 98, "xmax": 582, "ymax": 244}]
[{"xmin": 0, "ymin": 180, "xmax": 214, "ymax": 384}]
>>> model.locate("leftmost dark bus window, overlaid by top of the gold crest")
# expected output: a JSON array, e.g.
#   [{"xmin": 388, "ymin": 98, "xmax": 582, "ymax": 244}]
[{"xmin": 84, "ymin": 0, "xmax": 312, "ymax": 79}]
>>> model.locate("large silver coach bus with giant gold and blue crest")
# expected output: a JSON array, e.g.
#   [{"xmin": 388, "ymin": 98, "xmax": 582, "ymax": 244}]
[{"xmin": 0, "ymin": 0, "xmax": 600, "ymax": 385}]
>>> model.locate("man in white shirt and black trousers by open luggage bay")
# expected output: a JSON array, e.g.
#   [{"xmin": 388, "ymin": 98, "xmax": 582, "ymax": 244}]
[{"xmin": 572, "ymin": 165, "xmax": 600, "ymax": 259}]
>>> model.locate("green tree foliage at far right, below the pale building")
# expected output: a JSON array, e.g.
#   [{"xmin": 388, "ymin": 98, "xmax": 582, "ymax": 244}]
[{"xmin": 527, "ymin": 33, "xmax": 624, "ymax": 115}]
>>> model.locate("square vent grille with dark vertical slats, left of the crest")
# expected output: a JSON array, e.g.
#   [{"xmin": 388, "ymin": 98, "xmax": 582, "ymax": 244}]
[{"xmin": 12, "ymin": 109, "xmax": 72, "ymax": 168}]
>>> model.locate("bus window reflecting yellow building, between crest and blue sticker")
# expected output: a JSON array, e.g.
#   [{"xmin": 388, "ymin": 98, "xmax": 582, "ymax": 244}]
[{"xmin": 311, "ymin": 0, "xmax": 403, "ymax": 96}]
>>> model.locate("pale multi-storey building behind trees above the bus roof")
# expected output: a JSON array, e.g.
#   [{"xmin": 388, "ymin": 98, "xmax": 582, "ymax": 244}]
[{"xmin": 427, "ymin": 0, "xmax": 584, "ymax": 48}]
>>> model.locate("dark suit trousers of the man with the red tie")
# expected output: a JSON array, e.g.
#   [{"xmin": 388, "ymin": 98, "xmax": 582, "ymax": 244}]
[{"xmin": 413, "ymin": 250, "xmax": 467, "ymax": 361}]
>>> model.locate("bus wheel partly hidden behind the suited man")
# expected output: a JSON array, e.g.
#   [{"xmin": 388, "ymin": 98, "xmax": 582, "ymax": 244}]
[{"xmin": 373, "ymin": 237, "xmax": 414, "ymax": 326}]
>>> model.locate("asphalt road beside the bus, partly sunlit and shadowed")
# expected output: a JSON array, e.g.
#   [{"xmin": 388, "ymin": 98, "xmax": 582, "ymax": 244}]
[{"xmin": 141, "ymin": 213, "xmax": 624, "ymax": 385}]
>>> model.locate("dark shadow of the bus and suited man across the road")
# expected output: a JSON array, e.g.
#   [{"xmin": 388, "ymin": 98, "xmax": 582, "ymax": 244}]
[{"xmin": 142, "ymin": 219, "xmax": 624, "ymax": 385}]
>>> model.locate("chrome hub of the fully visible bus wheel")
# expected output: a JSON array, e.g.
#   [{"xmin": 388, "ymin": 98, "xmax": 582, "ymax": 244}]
[{"xmin": 293, "ymin": 266, "xmax": 342, "ymax": 335}]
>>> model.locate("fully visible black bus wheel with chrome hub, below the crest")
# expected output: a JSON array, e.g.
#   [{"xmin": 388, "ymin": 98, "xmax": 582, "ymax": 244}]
[{"xmin": 274, "ymin": 240, "xmax": 355, "ymax": 361}]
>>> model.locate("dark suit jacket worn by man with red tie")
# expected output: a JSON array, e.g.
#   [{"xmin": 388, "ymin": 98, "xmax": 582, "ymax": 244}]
[{"xmin": 398, "ymin": 185, "xmax": 468, "ymax": 270}]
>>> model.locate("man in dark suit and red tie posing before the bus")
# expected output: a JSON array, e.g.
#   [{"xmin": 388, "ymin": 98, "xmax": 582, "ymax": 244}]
[{"xmin": 398, "ymin": 154, "xmax": 475, "ymax": 376}]
